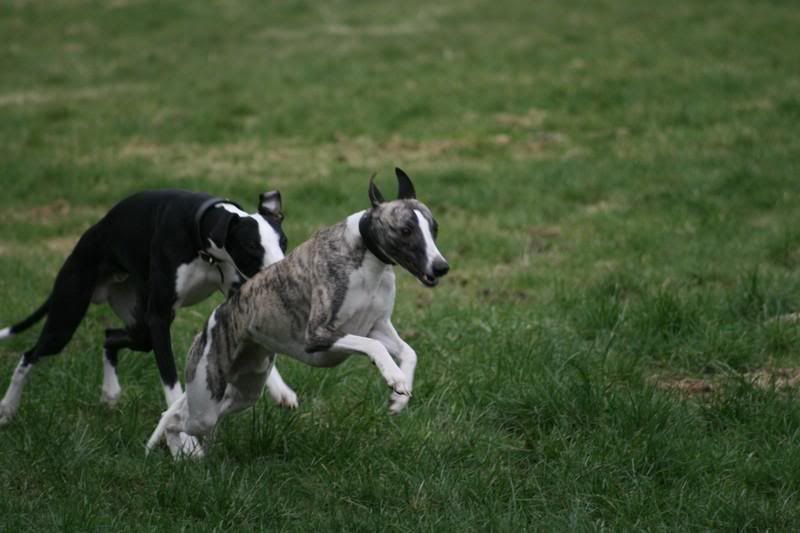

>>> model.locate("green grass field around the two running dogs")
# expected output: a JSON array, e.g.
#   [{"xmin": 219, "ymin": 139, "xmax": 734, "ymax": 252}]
[{"xmin": 0, "ymin": 0, "xmax": 800, "ymax": 532}]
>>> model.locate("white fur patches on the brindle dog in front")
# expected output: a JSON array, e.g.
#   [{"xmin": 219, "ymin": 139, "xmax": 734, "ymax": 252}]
[{"xmin": 147, "ymin": 211, "xmax": 443, "ymax": 457}]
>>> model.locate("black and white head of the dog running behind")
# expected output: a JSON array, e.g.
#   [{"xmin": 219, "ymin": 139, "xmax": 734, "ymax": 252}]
[{"xmin": 209, "ymin": 191, "xmax": 287, "ymax": 281}]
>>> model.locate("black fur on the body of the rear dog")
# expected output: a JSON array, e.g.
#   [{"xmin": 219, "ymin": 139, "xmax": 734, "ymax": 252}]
[{"xmin": 0, "ymin": 189, "xmax": 285, "ymax": 392}]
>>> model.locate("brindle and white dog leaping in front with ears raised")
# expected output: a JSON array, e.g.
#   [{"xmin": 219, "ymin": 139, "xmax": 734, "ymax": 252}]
[{"xmin": 147, "ymin": 169, "xmax": 450, "ymax": 456}]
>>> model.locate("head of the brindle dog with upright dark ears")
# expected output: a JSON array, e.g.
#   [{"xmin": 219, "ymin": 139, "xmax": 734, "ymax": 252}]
[{"xmin": 361, "ymin": 168, "xmax": 450, "ymax": 287}]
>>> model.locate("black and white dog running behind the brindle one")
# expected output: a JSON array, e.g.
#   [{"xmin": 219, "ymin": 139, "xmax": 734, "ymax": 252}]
[{"xmin": 0, "ymin": 190, "xmax": 297, "ymax": 425}]
